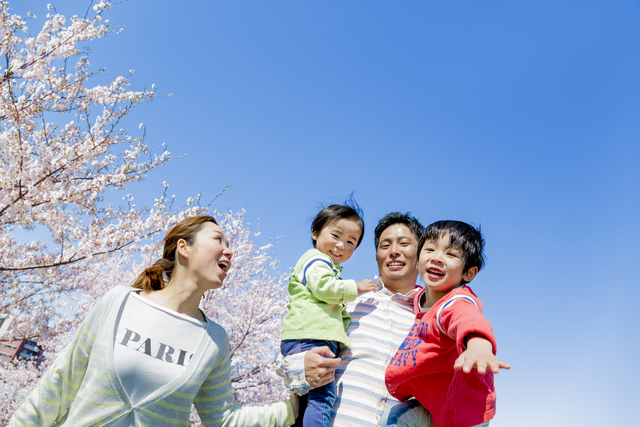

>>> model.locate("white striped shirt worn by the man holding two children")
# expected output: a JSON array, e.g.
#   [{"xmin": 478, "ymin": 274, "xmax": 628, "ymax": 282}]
[{"xmin": 281, "ymin": 278, "xmax": 418, "ymax": 427}]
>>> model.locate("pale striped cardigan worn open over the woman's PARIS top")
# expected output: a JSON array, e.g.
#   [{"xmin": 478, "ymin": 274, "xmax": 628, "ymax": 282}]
[{"xmin": 8, "ymin": 286, "xmax": 294, "ymax": 427}]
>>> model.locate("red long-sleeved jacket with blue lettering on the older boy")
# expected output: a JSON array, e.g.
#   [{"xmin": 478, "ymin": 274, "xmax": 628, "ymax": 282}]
[{"xmin": 385, "ymin": 286, "xmax": 496, "ymax": 427}]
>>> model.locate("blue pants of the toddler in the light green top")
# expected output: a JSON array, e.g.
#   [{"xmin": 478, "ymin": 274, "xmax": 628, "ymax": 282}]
[{"xmin": 280, "ymin": 340, "xmax": 338, "ymax": 427}]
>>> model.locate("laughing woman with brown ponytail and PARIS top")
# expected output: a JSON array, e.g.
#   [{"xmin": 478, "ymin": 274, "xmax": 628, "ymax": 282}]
[{"xmin": 9, "ymin": 215, "xmax": 297, "ymax": 427}]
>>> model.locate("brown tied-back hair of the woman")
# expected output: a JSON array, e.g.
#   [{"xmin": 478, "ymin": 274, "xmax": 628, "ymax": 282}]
[{"xmin": 133, "ymin": 215, "xmax": 218, "ymax": 291}]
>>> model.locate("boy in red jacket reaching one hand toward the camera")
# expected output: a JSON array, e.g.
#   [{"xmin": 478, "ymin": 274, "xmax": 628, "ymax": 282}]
[{"xmin": 382, "ymin": 221, "xmax": 510, "ymax": 427}]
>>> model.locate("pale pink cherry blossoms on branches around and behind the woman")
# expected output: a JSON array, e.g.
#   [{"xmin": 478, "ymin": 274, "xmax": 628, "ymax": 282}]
[{"xmin": 0, "ymin": 0, "xmax": 286, "ymax": 425}]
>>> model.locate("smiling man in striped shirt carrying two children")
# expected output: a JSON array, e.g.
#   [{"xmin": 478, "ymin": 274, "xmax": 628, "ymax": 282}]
[{"xmin": 282, "ymin": 212, "xmax": 423, "ymax": 427}]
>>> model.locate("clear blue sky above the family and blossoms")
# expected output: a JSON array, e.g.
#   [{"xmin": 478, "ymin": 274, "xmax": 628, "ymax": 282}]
[{"xmin": 13, "ymin": 0, "xmax": 640, "ymax": 427}]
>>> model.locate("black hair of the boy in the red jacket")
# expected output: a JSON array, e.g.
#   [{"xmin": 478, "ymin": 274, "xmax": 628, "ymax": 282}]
[{"xmin": 418, "ymin": 221, "xmax": 485, "ymax": 284}]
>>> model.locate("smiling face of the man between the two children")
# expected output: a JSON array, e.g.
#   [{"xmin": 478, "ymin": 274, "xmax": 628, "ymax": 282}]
[{"xmin": 376, "ymin": 224, "xmax": 418, "ymax": 284}]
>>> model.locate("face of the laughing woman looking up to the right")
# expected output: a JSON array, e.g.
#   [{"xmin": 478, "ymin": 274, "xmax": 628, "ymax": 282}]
[{"xmin": 186, "ymin": 222, "xmax": 233, "ymax": 289}]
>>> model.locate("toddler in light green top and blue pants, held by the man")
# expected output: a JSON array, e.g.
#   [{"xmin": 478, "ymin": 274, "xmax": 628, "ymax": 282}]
[{"xmin": 280, "ymin": 203, "xmax": 377, "ymax": 427}]
